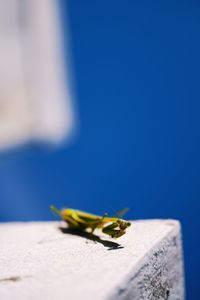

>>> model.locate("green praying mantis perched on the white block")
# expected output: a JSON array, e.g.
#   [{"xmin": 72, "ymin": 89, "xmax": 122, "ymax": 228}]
[{"xmin": 50, "ymin": 206, "xmax": 131, "ymax": 238}]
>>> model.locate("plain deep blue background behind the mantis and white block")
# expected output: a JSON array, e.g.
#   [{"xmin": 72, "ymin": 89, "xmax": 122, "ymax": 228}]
[{"xmin": 0, "ymin": 0, "xmax": 200, "ymax": 299}]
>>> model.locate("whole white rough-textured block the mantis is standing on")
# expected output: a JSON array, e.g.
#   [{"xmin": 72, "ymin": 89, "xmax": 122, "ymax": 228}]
[{"xmin": 0, "ymin": 220, "xmax": 184, "ymax": 300}]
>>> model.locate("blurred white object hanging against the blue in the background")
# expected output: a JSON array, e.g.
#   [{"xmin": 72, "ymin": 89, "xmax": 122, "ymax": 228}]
[{"xmin": 0, "ymin": 0, "xmax": 74, "ymax": 149}]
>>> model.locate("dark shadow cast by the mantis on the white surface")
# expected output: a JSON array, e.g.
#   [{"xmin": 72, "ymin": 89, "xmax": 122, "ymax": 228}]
[{"xmin": 59, "ymin": 227, "xmax": 124, "ymax": 250}]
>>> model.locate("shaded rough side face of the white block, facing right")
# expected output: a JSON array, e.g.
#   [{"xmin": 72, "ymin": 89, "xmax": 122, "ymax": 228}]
[{"xmin": 107, "ymin": 220, "xmax": 185, "ymax": 300}]
